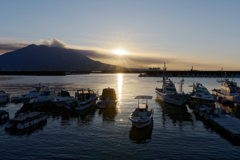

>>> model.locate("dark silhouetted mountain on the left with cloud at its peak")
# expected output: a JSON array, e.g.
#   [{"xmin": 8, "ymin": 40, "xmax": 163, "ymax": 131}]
[{"xmin": 0, "ymin": 44, "xmax": 126, "ymax": 71}]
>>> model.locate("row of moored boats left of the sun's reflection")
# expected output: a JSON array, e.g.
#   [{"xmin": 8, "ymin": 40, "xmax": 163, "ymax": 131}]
[{"xmin": 0, "ymin": 83, "xmax": 121, "ymax": 110}]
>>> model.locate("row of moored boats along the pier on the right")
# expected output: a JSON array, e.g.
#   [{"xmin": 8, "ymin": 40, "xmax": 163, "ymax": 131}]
[{"xmin": 155, "ymin": 63, "xmax": 240, "ymax": 106}]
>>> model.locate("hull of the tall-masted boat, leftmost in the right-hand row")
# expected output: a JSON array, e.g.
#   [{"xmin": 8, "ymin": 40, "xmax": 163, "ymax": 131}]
[{"xmin": 155, "ymin": 89, "xmax": 191, "ymax": 106}]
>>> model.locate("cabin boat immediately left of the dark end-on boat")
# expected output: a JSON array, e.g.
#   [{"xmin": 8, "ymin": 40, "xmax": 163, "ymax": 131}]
[{"xmin": 64, "ymin": 88, "xmax": 98, "ymax": 111}]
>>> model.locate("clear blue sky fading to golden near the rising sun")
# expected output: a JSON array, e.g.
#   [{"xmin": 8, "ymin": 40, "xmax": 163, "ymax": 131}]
[{"xmin": 0, "ymin": 0, "xmax": 240, "ymax": 70}]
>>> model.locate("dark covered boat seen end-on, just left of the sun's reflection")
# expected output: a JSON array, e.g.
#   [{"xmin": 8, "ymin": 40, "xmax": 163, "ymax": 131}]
[{"xmin": 97, "ymin": 87, "xmax": 117, "ymax": 108}]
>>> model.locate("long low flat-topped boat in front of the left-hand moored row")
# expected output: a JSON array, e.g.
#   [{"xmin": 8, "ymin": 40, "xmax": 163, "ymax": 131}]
[{"xmin": 5, "ymin": 112, "xmax": 47, "ymax": 130}]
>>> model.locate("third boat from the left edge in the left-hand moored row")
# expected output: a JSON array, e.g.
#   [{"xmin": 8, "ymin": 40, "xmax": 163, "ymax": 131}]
[{"xmin": 27, "ymin": 89, "xmax": 57, "ymax": 108}]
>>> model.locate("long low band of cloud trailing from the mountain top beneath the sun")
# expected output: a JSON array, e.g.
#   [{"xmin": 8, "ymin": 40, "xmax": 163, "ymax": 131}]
[{"xmin": 0, "ymin": 37, "xmax": 218, "ymax": 69}]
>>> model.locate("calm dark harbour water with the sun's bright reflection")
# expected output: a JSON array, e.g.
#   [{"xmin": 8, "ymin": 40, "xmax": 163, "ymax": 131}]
[{"xmin": 0, "ymin": 74, "xmax": 240, "ymax": 159}]
